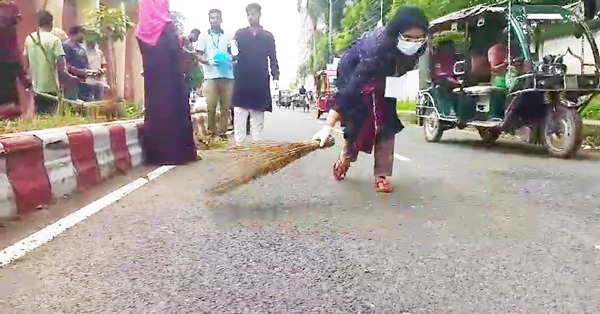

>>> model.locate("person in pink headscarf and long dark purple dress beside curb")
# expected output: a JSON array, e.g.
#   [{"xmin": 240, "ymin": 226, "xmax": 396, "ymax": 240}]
[{"xmin": 135, "ymin": 0, "xmax": 199, "ymax": 165}]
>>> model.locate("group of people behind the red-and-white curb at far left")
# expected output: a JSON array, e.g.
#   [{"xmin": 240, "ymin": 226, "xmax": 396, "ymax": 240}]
[{"xmin": 0, "ymin": 3, "xmax": 109, "ymax": 118}]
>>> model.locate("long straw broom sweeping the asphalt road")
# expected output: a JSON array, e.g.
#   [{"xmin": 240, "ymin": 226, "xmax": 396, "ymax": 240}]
[{"xmin": 207, "ymin": 136, "xmax": 335, "ymax": 195}]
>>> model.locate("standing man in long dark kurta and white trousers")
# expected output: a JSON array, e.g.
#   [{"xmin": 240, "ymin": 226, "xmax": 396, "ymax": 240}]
[{"xmin": 233, "ymin": 3, "xmax": 279, "ymax": 145}]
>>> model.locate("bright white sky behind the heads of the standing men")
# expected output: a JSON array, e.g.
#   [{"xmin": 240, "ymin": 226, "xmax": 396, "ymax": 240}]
[{"xmin": 171, "ymin": 0, "xmax": 300, "ymax": 87}]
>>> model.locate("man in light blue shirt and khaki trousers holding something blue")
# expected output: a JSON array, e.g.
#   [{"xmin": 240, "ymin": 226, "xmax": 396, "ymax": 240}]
[{"xmin": 196, "ymin": 9, "xmax": 233, "ymax": 139}]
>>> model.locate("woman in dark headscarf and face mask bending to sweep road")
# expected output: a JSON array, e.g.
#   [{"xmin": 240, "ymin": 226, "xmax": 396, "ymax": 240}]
[{"xmin": 313, "ymin": 7, "xmax": 429, "ymax": 192}]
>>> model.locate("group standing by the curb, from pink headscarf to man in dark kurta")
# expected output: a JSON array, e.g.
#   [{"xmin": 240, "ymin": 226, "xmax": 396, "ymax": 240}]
[{"xmin": 136, "ymin": 0, "xmax": 279, "ymax": 165}]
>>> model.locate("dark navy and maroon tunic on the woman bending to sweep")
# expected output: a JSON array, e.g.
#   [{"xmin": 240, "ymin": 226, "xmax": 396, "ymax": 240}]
[{"xmin": 334, "ymin": 28, "xmax": 422, "ymax": 153}]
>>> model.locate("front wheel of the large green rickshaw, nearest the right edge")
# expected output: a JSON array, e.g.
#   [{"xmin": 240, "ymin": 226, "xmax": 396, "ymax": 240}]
[{"xmin": 544, "ymin": 105, "xmax": 583, "ymax": 159}]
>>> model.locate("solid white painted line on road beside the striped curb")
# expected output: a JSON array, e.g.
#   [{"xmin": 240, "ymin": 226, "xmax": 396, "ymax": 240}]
[{"xmin": 0, "ymin": 166, "xmax": 175, "ymax": 267}]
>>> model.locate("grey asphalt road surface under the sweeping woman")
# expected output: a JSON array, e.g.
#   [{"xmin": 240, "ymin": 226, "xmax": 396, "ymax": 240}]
[{"xmin": 0, "ymin": 109, "xmax": 600, "ymax": 313}]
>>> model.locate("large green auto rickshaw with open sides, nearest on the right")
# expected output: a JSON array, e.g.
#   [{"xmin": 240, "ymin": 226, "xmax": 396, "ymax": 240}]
[{"xmin": 416, "ymin": 1, "xmax": 600, "ymax": 158}]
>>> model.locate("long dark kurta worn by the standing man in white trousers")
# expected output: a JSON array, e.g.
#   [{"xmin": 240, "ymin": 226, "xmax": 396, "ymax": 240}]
[{"xmin": 232, "ymin": 27, "xmax": 279, "ymax": 112}]
